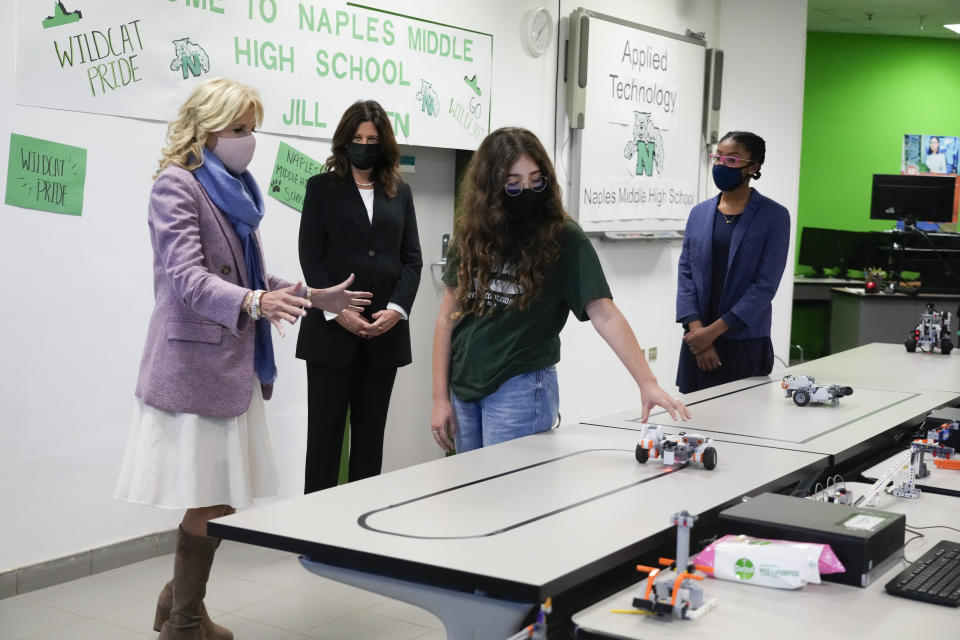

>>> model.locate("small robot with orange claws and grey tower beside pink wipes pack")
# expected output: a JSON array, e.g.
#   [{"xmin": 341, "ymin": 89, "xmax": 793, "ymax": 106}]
[{"xmin": 633, "ymin": 511, "xmax": 717, "ymax": 620}]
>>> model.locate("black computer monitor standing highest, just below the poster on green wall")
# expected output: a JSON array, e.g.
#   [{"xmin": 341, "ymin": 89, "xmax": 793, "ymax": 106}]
[{"xmin": 870, "ymin": 174, "xmax": 956, "ymax": 222}]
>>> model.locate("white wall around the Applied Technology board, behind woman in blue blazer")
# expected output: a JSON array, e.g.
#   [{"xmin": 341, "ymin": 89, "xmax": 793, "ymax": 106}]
[{"xmin": 557, "ymin": 0, "xmax": 807, "ymax": 422}]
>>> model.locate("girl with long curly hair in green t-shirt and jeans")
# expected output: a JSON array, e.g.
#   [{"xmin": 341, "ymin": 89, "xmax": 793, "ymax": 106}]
[{"xmin": 430, "ymin": 127, "xmax": 689, "ymax": 452}]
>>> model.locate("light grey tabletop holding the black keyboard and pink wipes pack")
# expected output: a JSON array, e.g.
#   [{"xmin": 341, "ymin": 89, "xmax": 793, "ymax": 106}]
[{"xmin": 572, "ymin": 483, "xmax": 960, "ymax": 640}]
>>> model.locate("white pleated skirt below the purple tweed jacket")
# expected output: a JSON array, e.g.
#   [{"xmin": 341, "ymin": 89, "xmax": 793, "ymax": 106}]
[{"xmin": 114, "ymin": 382, "xmax": 279, "ymax": 509}]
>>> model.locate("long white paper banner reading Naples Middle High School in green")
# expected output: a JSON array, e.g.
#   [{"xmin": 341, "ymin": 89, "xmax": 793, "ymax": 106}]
[{"xmin": 17, "ymin": 0, "xmax": 493, "ymax": 149}]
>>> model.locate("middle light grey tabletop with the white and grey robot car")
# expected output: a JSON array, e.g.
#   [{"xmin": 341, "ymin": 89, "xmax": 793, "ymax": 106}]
[{"xmin": 589, "ymin": 378, "xmax": 960, "ymax": 464}]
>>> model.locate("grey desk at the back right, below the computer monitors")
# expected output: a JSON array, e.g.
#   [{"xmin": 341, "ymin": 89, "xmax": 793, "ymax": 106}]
[{"xmin": 830, "ymin": 287, "xmax": 960, "ymax": 353}]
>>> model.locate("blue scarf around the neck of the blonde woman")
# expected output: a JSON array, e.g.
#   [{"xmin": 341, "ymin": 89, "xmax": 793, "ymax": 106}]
[{"xmin": 193, "ymin": 149, "xmax": 277, "ymax": 384}]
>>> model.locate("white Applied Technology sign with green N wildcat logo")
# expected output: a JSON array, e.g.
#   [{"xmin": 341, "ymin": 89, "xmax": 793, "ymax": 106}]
[{"xmin": 577, "ymin": 20, "xmax": 703, "ymax": 222}]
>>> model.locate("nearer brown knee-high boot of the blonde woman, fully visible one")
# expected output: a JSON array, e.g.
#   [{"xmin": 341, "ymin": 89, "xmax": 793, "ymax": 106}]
[{"xmin": 154, "ymin": 527, "xmax": 233, "ymax": 640}]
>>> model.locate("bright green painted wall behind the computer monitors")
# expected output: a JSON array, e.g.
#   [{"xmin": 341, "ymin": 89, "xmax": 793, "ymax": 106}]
[{"xmin": 792, "ymin": 32, "xmax": 960, "ymax": 359}]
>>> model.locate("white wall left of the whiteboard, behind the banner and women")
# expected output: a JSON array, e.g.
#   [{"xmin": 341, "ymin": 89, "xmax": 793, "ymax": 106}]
[{"xmin": 0, "ymin": 0, "xmax": 556, "ymax": 572}]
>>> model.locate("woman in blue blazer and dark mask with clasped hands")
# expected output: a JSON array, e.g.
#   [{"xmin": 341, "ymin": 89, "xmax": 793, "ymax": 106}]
[{"xmin": 677, "ymin": 131, "xmax": 790, "ymax": 393}]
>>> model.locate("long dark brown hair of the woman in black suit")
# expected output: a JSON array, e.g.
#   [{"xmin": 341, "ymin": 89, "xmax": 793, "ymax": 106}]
[{"xmin": 326, "ymin": 100, "xmax": 401, "ymax": 198}]
